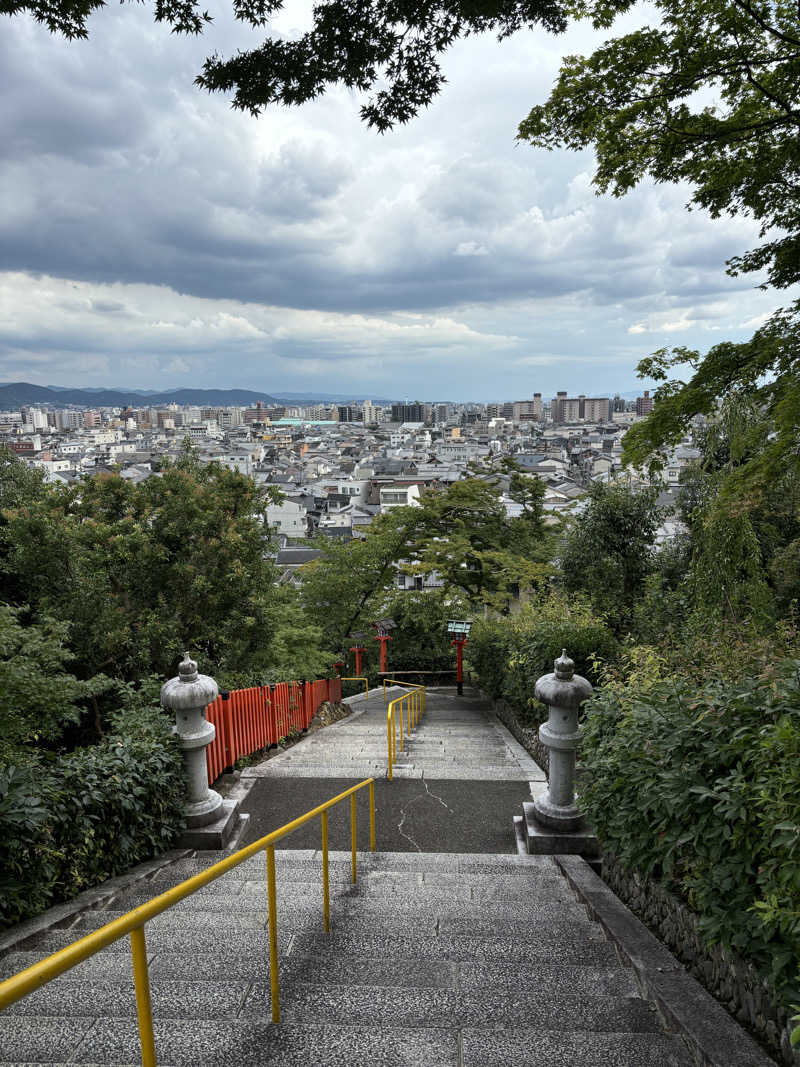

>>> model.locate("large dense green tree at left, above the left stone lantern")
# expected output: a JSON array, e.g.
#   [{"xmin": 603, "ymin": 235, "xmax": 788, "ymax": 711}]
[{"xmin": 3, "ymin": 459, "xmax": 288, "ymax": 681}]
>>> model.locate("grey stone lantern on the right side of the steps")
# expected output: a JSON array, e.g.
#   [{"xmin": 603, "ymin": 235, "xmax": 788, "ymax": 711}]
[{"xmin": 533, "ymin": 649, "xmax": 593, "ymax": 831}]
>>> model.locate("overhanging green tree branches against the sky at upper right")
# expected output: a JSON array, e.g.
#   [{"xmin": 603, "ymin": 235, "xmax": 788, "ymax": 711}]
[{"xmin": 519, "ymin": 0, "xmax": 800, "ymax": 491}]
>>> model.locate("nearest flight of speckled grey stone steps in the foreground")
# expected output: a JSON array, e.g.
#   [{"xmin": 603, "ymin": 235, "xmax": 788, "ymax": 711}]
[{"xmin": 0, "ymin": 850, "xmax": 692, "ymax": 1067}]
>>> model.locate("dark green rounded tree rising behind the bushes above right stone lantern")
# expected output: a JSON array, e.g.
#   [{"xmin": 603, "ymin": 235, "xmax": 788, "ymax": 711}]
[{"xmin": 561, "ymin": 482, "xmax": 661, "ymax": 628}]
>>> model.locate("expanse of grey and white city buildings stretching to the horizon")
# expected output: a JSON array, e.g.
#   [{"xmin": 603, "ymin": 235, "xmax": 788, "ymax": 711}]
[{"xmin": 0, "ymin": 392, "xmax": 699, "ymax": 587}]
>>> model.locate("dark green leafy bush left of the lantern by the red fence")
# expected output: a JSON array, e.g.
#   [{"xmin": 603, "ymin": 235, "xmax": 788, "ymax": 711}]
[{"xmin": 0, "ymin": 710, "xmax": 186, "ymax": 926}]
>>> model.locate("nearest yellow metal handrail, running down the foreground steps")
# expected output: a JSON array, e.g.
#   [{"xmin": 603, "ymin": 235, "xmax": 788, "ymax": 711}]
[{"xmin": 0, "ymin": 778, "xmax": 375, "ymax": 1067}]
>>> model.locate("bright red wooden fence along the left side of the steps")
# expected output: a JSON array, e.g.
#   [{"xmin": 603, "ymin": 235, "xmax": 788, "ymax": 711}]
[{"xmin": 206, "ymin": 678, "xmax": 341, "ymax": 782}]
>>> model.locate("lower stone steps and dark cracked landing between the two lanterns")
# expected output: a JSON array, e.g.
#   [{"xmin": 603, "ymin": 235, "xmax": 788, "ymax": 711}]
[{"xmin": 242, "ymin": 687, "xmax": 545, "ymax": 854}]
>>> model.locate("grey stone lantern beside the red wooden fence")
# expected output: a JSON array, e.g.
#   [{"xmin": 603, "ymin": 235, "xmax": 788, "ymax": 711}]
[{"xmin": 161, "ymin": 652, "xmax": 224, "ymax": 830}]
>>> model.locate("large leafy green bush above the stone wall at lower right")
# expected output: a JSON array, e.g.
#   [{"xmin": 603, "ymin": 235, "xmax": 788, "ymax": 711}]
[{"xmin": 581, "ymin": 659, "xmax": 800, "ymax": 1003}]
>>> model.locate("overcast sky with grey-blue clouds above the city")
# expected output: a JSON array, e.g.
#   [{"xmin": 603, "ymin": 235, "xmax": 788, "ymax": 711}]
[{"xmin": 0, "ymin": 3, "xmax": 777, "ymax": 400}]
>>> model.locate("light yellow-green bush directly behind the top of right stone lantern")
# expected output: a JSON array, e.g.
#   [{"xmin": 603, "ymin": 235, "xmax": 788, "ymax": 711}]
[{"xmin": 466, "ymin": 593, "xmax": 619, "ymax": 719}]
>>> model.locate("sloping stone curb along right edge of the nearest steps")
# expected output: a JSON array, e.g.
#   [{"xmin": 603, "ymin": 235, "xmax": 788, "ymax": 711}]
[{"xmin": 554, "ymin": 856, "xmax": 775, "ymax": 1067}]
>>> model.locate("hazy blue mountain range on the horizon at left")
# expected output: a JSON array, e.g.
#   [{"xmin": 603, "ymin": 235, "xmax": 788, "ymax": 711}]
[{"xmin": 0, "ymin": 382, "xmax": 279, "ymax": 411}]
